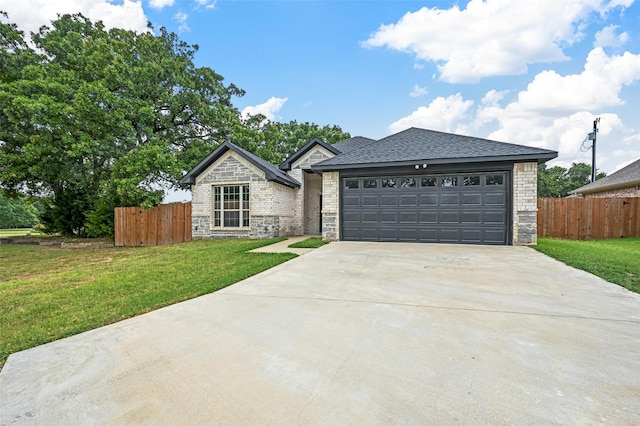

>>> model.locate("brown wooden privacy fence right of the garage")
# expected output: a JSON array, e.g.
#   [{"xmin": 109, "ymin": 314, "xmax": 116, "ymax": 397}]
[{"xmin": 538, "ymin": 198, "xmax": 640, "ymax": 240}]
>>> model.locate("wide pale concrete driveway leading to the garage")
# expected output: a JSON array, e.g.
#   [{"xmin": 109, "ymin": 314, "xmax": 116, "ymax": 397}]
[{"xmin": 0, "ymin": 242, "xmax": 640, "ymax": 425}]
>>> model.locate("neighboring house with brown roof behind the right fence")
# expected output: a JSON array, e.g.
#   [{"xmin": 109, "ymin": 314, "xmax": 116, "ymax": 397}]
[{"xmin": 571, "ymin": 159, "xmax": 640, "ymax": 198}]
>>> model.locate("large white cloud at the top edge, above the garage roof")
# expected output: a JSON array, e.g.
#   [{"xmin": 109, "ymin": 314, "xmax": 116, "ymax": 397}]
[{"xmin": 363, "ymin": 0, "xmax": 633, "ymax": 83}]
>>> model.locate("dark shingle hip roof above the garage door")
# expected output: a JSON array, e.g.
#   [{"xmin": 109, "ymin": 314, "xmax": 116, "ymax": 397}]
[{"xmin": 312, "ymin": 127, "xmax": 558, "ymax": 171}]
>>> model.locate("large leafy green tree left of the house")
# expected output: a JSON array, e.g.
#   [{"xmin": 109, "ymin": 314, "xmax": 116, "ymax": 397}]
[{"xmin": 0, "ymin": 15, "xmax": 244, "ymax": 235}]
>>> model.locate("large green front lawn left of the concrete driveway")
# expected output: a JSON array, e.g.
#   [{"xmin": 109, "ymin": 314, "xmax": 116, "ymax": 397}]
[{"xmin": 0, "ymin": 238, "xmax": 296, "ymax": 368}]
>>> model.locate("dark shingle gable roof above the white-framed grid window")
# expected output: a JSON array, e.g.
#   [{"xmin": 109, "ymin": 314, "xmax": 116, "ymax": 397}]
[{"xmin": 180, "ymin": 141, "xmax": 300, "ymax": 188}]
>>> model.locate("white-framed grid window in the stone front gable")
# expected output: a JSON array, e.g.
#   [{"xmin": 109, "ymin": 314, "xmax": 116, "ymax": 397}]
[{"xmin": 213, "ymin": 185, "xmax": 249, "ymax": 228}]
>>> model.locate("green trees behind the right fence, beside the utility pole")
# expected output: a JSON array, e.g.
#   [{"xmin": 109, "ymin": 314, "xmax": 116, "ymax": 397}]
[{"xmin": 538, "ymin": 163, "xmax": 606, "ymax": 198}]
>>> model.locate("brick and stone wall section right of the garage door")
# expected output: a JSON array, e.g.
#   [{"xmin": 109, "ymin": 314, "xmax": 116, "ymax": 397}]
[{"xmin": 513, "ymin": 163, "xmax": 538, "ymax": 245}]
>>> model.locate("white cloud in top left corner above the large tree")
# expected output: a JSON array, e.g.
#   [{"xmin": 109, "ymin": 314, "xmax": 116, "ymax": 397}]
[{"xmin": 0, "ymin": 0, "xmax": 148, "ymax": 36}]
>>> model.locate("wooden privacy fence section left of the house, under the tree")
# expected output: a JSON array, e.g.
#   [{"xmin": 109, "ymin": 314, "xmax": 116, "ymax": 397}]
[{"xmin": 114, "ymin": 203, "xmax": 191, "ymax": 247}]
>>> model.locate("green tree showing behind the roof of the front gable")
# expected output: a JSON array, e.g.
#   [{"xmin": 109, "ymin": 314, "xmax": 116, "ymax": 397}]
[{"xmin": 231, "ymin": 114, "xmax": 351, "ymax": 164}]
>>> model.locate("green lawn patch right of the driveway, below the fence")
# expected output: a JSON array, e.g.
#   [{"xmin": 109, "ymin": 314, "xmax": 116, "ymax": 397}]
[{"xmin": 534, "ymin": 238, "xmax": 640, "ymax": 293}]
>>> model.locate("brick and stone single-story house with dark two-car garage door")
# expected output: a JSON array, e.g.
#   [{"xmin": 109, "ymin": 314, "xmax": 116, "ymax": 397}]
[{"xmin": 181, "ymin": 128, "xmax": 558, "ymax": 244}]
